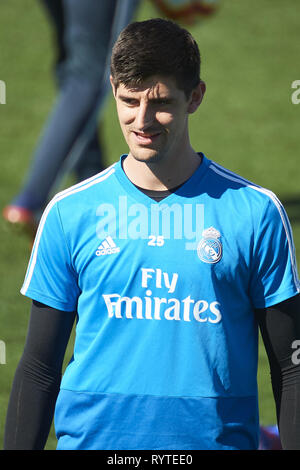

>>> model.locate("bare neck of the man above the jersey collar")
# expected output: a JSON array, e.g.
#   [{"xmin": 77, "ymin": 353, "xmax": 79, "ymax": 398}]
[{"xmin": 123, "ymin": 149, "xmax": 202, "ymax": 191}]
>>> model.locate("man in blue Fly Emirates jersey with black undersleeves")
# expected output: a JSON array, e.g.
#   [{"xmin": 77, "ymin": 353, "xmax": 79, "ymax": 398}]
[{"xmin": 5, "ymin": 19, "xmax": 300, "ymax": 450}]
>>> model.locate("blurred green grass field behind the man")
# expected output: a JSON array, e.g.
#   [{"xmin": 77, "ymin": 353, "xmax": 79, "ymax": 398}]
[{"xmin": 0, "ymin": 0, "xmax": 300, "ymax": 449}]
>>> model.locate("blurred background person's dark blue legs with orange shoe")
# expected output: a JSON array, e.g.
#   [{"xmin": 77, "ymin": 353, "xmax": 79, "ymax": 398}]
[{"xmin": 3, "ymin": 0, "xmax": 140, "ymax": 234}]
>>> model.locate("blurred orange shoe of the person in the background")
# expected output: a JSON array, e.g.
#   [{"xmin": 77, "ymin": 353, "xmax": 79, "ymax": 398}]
[{"xmin": 2, "ymin": 205, "xmax": 37, "ymax": 237}]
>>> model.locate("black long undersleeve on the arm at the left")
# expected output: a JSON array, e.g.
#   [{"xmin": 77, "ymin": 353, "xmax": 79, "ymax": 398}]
[{"xmin": 4, "ymin": 302, "xmax": 76, "ymax": 450}]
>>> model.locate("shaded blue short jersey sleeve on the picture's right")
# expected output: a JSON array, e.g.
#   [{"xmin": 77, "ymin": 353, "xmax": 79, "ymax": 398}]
[{"xmin": 250, "ymin": 196, "xmax": 300, "ymax": 308}]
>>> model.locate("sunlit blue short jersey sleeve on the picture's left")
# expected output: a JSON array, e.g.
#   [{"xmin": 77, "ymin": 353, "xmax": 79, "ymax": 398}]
[{"xmin": 21, "ymin": 201, "xmax": 79, "ymax": 311}]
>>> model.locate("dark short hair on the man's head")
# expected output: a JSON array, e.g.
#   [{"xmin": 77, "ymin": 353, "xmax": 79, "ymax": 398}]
[{"xmin": 111, "ymin": 18, "xmax": 201, "ymax": 98}]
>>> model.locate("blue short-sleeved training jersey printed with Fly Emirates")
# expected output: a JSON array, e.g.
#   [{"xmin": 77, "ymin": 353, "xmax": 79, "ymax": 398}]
[{"xmin": 21, "ymin": 155, "xmax": 300, "ymax": 450}]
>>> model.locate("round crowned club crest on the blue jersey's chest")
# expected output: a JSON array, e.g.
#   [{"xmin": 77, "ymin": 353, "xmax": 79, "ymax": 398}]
[{"xmin": 197, "ymin": 227, "xmax": 222, "ymax": 264}]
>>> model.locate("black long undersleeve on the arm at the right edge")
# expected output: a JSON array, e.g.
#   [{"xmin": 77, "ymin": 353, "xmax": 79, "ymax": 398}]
[{"xmin": 256, "ymin": 295, "xmax": 300, "ymax": 450}]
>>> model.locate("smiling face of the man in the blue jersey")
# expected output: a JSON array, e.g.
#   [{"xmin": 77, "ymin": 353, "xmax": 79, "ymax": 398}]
[{"xmin": 113, "ymin": 77, "xmax": 198, "ymax": 163}]
